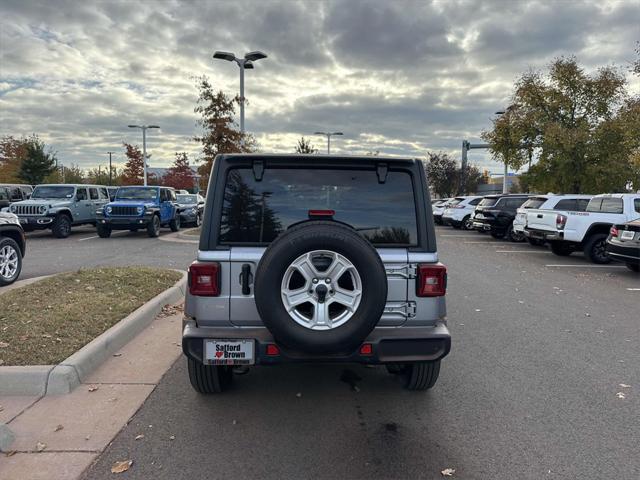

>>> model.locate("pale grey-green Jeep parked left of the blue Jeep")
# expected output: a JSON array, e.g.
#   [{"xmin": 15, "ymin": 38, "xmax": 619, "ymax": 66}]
[{"xmin": 10, "ymin": 184, "xmax": 109, "ymax": 238}]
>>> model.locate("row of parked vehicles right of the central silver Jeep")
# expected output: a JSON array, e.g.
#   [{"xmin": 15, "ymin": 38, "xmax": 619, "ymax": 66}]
[{"xmin": 432, "ymin": 193, "xmax": 640, "ymax": 272}]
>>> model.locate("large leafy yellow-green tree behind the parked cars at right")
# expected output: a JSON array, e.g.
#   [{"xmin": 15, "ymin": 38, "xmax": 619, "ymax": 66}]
[{"xmin": 483, "ymin": 57, "xmax": 638, "ymax": 193}]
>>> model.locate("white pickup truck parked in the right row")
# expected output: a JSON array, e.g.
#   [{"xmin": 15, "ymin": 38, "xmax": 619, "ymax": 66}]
[{"xmin": 524, "ymin": 193, "xmax": 640, "ymax": 263}]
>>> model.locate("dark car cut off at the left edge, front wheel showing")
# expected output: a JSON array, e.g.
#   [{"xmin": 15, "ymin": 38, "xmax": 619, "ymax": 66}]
[{"xmin": 0, "ymin": 212, "xmax": 27, "ymax": 287}]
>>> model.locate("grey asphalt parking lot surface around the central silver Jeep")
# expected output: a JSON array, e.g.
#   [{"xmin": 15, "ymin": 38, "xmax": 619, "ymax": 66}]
[{"xmin": 57, "ymin": 227, "xmax": 640, "ymax": 479}]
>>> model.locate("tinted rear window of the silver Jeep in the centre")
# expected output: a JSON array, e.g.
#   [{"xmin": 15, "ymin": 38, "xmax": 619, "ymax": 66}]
[{"xmin": 220, "ymin": 168, "xmax": 418, "ymax": 246}]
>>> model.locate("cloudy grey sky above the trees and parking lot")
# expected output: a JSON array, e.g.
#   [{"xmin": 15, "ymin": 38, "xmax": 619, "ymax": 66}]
[{"xmin": 0, "ymin": 0, "xmax": 640, "ymax": 172}]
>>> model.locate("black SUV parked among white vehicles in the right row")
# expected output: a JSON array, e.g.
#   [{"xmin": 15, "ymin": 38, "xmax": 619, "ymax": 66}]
[{"xmin": 473, "ymin": 194, "xmax": 529, "ymax": 242}]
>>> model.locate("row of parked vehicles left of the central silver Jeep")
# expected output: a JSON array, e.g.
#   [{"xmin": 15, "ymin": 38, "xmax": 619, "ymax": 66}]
[{"xmin": 0, "ymin": 184, "xmax": 204, "ymax": 286}]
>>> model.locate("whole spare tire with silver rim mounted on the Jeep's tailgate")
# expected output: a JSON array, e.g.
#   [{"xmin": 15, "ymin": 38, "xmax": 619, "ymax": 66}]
[{"xmin": 255, "ymin": 221, "xmax": 387, "ymax": 353}]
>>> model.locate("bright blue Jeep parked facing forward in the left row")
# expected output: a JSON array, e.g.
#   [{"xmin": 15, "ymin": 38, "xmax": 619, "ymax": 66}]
[{"xmin": 96, "ymin": 187, "xmax": 180, "ymax": 238}]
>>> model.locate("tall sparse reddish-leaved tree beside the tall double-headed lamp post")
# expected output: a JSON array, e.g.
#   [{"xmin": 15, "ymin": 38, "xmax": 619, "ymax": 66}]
[{"xmin": 194, "ymin": 76, "xmax": 256, "ymax": 186}]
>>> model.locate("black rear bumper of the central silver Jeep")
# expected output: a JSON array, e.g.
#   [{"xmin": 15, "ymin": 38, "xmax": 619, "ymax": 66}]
[{"xmin": 182, "ymin": 320, "xmax": 451, "ymax": 365}]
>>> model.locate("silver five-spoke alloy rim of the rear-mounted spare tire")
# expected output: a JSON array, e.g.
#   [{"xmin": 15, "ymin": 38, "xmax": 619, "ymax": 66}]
[{"xmin": 281, "ymin": 250, "xmax": 362, "ymax": 330}]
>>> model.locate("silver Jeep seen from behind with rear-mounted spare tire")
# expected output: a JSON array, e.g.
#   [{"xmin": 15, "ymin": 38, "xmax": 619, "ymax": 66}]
[{"xmin": 182, "ymin": 155, "xmax": 451, "ymax": 393}]
